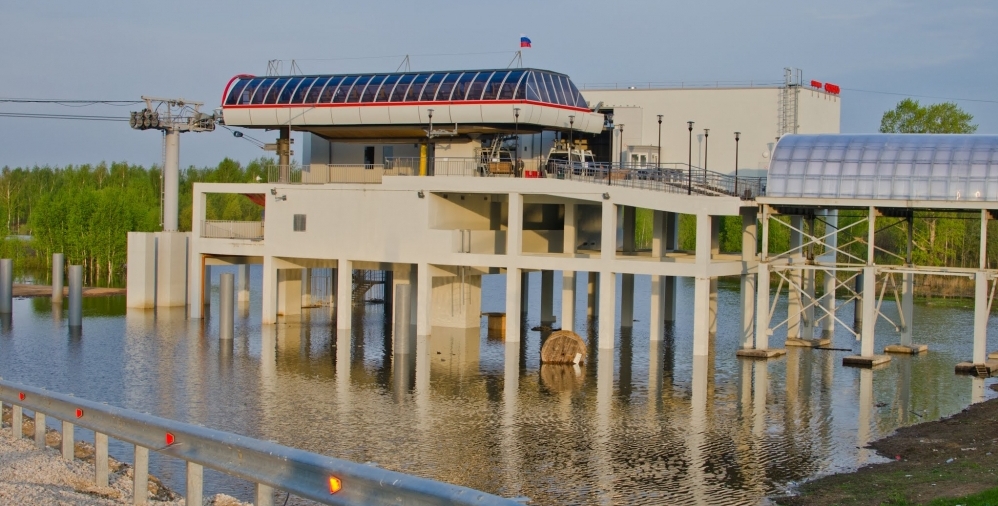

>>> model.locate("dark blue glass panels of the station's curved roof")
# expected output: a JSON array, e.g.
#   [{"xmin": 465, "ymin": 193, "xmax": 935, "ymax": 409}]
[{"xmin": 224, "ymin": 69, "xmax": 586, "ymax": 108}]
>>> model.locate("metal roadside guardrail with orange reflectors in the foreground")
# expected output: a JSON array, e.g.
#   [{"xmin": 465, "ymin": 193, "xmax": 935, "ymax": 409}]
[{"xmin": 0, "ymin": 380, "xmax": 522, "ymax": 506}]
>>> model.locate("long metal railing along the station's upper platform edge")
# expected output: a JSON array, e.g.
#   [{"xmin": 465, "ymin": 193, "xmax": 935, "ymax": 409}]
[{"xmin": 268, "ymin": 158, "xmax": 765, "ymax": 200}]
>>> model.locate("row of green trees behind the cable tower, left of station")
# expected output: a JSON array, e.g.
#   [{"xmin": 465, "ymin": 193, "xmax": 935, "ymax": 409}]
[{"xmin": 0, "ymin": 158, "xmax": 275, "ymax": 285}]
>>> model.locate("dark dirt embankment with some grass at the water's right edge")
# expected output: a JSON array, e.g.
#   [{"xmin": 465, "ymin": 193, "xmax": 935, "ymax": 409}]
[{"xmin": 774, "ymin": 386, "xmax": 998, "ymax": 506}]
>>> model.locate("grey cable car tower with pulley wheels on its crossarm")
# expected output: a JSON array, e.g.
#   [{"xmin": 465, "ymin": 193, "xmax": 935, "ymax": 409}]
[{"xmin": 128, "ymin": 96, "xmax": 216, "ymax": 232}]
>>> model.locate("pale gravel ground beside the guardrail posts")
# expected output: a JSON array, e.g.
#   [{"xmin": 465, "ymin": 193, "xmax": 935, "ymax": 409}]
[{"xmin": 0, "ymin": 407, "xmax": 252, "ymax": 506}]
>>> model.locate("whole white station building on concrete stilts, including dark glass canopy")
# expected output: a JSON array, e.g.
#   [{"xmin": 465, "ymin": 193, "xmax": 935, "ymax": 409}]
[{"xmin": 128, "ymin": 69, "xmax": 840, "ymax": 355}]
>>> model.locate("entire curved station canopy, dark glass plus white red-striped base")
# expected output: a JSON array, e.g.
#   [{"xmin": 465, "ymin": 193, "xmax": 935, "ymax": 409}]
[{"xmin": 222, "ymin": 69, "xmax": 604, "ymax": 139}]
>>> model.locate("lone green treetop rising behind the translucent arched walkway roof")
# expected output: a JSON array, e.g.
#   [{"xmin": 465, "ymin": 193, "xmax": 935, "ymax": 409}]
[{"xmin": 880, "ymin": 98, "xmax": 977, "ymax": 134}]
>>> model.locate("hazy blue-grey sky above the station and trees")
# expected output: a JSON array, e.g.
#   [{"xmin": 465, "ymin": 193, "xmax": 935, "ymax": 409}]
[{"xmin": 0, "ymin": 0, "xmax": 998, "ymax": 166}]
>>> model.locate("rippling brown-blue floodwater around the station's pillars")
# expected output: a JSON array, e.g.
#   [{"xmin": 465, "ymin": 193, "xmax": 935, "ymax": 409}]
[{"xmin": 0, "ymin": 267, "xmax": 996, "ymax": 504}]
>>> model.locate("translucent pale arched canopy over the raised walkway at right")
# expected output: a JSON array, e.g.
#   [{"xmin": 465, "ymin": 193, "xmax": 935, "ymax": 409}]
[{"xmin": 766, "ymin": 134, "xmax": 998, "ymax": 202}]
